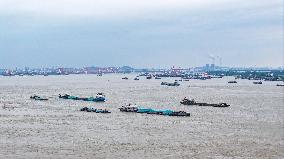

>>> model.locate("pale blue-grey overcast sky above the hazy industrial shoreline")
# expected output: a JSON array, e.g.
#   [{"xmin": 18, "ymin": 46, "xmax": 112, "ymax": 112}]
[{"xmin": 0, "ymin": 0, "xmax": 284, "ymax": 68}]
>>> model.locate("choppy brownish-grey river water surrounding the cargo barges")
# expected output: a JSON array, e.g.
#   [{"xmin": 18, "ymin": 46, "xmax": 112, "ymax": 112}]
[{"xmin": 0, "ymin": 75, "xmax": 284, "ymax": 159}]
